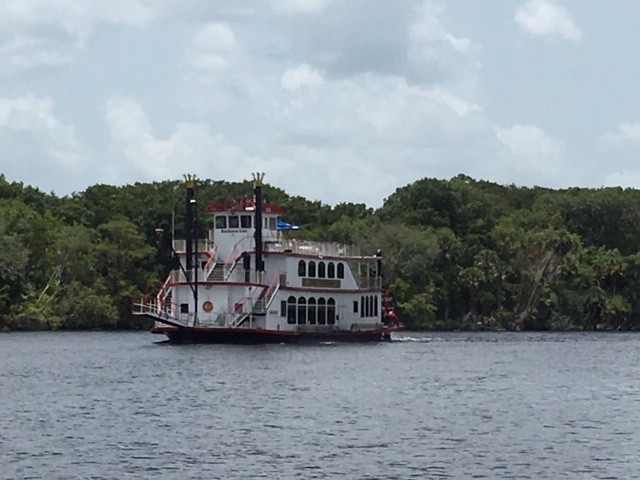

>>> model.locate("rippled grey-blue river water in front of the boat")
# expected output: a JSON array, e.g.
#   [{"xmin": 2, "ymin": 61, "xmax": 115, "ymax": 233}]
[{"xmin": 0, "ymin": 333, "xmax": 640, "ymax": 479}]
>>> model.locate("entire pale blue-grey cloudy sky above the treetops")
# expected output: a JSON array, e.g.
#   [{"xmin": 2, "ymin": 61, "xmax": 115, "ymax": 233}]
[{"xmin": 0, "ymin": 0, "xmax": 640, "ymax": 207}]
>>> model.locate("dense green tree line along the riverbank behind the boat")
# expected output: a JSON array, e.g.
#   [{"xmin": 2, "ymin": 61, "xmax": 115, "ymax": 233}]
[{"xmin": 0, "ymin": 175, "xmax": 640, "ymax": 330}]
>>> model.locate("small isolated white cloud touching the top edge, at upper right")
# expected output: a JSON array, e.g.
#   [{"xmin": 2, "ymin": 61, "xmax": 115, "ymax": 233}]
[{"xmin": 515, "ymin": 0, "xmax": 582, "ymax": 42}]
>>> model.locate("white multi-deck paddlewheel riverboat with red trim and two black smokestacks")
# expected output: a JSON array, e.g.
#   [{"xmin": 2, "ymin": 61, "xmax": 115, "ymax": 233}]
[{"xmin": 134, "ymin": 174, "xmax": 400, "ymax": 343}]
